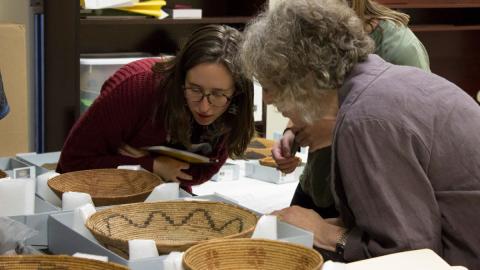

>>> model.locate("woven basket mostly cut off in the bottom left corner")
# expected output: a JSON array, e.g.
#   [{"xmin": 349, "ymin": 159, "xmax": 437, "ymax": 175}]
[{"xmin": 0, "ymin": 255, "xmax": 128, "ymax": 270}]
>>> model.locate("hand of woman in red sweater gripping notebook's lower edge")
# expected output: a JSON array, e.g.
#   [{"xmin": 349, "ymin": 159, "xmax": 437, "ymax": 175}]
[{"xmin": 153, "ymin": 156, "xmax": 192, "ymax": 182}]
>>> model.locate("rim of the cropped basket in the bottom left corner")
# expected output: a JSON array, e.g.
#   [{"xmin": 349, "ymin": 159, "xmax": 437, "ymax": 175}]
[{"xmin": 0, "ymin": 254, "xmax": 129, "ymax": 270}]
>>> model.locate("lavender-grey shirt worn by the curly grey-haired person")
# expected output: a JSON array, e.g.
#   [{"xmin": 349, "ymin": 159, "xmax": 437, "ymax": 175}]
[{"xmin": 332, "ymin": 55, "xmax": 480, "ymax": 269}]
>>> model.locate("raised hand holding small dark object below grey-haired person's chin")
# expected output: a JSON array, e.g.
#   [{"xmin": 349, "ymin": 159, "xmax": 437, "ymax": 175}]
[{"xmin": 272, "ymin": 129, "xmax": 301, "ymax": 173}]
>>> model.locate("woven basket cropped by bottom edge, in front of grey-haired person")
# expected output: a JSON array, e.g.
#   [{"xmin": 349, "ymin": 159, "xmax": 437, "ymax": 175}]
[{"xmin": 183, "ymin": 239, "xmax": 323, "ymax": 270}]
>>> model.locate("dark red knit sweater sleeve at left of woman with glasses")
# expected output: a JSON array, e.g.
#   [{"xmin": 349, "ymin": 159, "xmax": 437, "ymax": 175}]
[{"xmin": 57, "ymin": 59, "xmax": 159, "ymax": 173}]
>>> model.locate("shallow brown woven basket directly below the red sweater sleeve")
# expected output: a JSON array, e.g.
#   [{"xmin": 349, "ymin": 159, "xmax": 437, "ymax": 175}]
[{"xmin": 48, "ymin": 169, "xmax": 163, "ymax": 206}]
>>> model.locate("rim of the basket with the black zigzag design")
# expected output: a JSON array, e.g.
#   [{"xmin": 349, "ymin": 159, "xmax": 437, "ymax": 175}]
[{"xmin": 85, "ymin": 200, "xmax": 258, "ymax": 247}]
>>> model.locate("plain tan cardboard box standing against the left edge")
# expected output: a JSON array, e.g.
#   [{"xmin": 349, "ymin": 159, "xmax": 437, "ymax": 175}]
[{"xmin": 0, "ymin": 23, "xmax": 30, "ymax": 156}]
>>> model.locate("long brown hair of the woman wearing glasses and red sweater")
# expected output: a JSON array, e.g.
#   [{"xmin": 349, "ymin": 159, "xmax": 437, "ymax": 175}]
[{"xmin": 153, "ymin": 25, "xmax": 255, "ymax": 157}]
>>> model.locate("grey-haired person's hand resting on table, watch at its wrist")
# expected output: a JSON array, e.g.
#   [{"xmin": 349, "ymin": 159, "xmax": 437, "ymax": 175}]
[{"xmin": 272, "ymin": 205, "xmax": 346, "ymax": 251}]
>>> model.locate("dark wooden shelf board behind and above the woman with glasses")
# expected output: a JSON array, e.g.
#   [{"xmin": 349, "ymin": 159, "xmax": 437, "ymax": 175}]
[{"xmin": 80, "ymin": 16, "xmax": 252, "ymax": 25}]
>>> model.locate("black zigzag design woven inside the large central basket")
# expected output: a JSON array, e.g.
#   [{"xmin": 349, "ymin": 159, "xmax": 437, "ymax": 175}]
[{"xmin": 103, "ymin": 208, "xmax": 244, "ymax": 236}]
